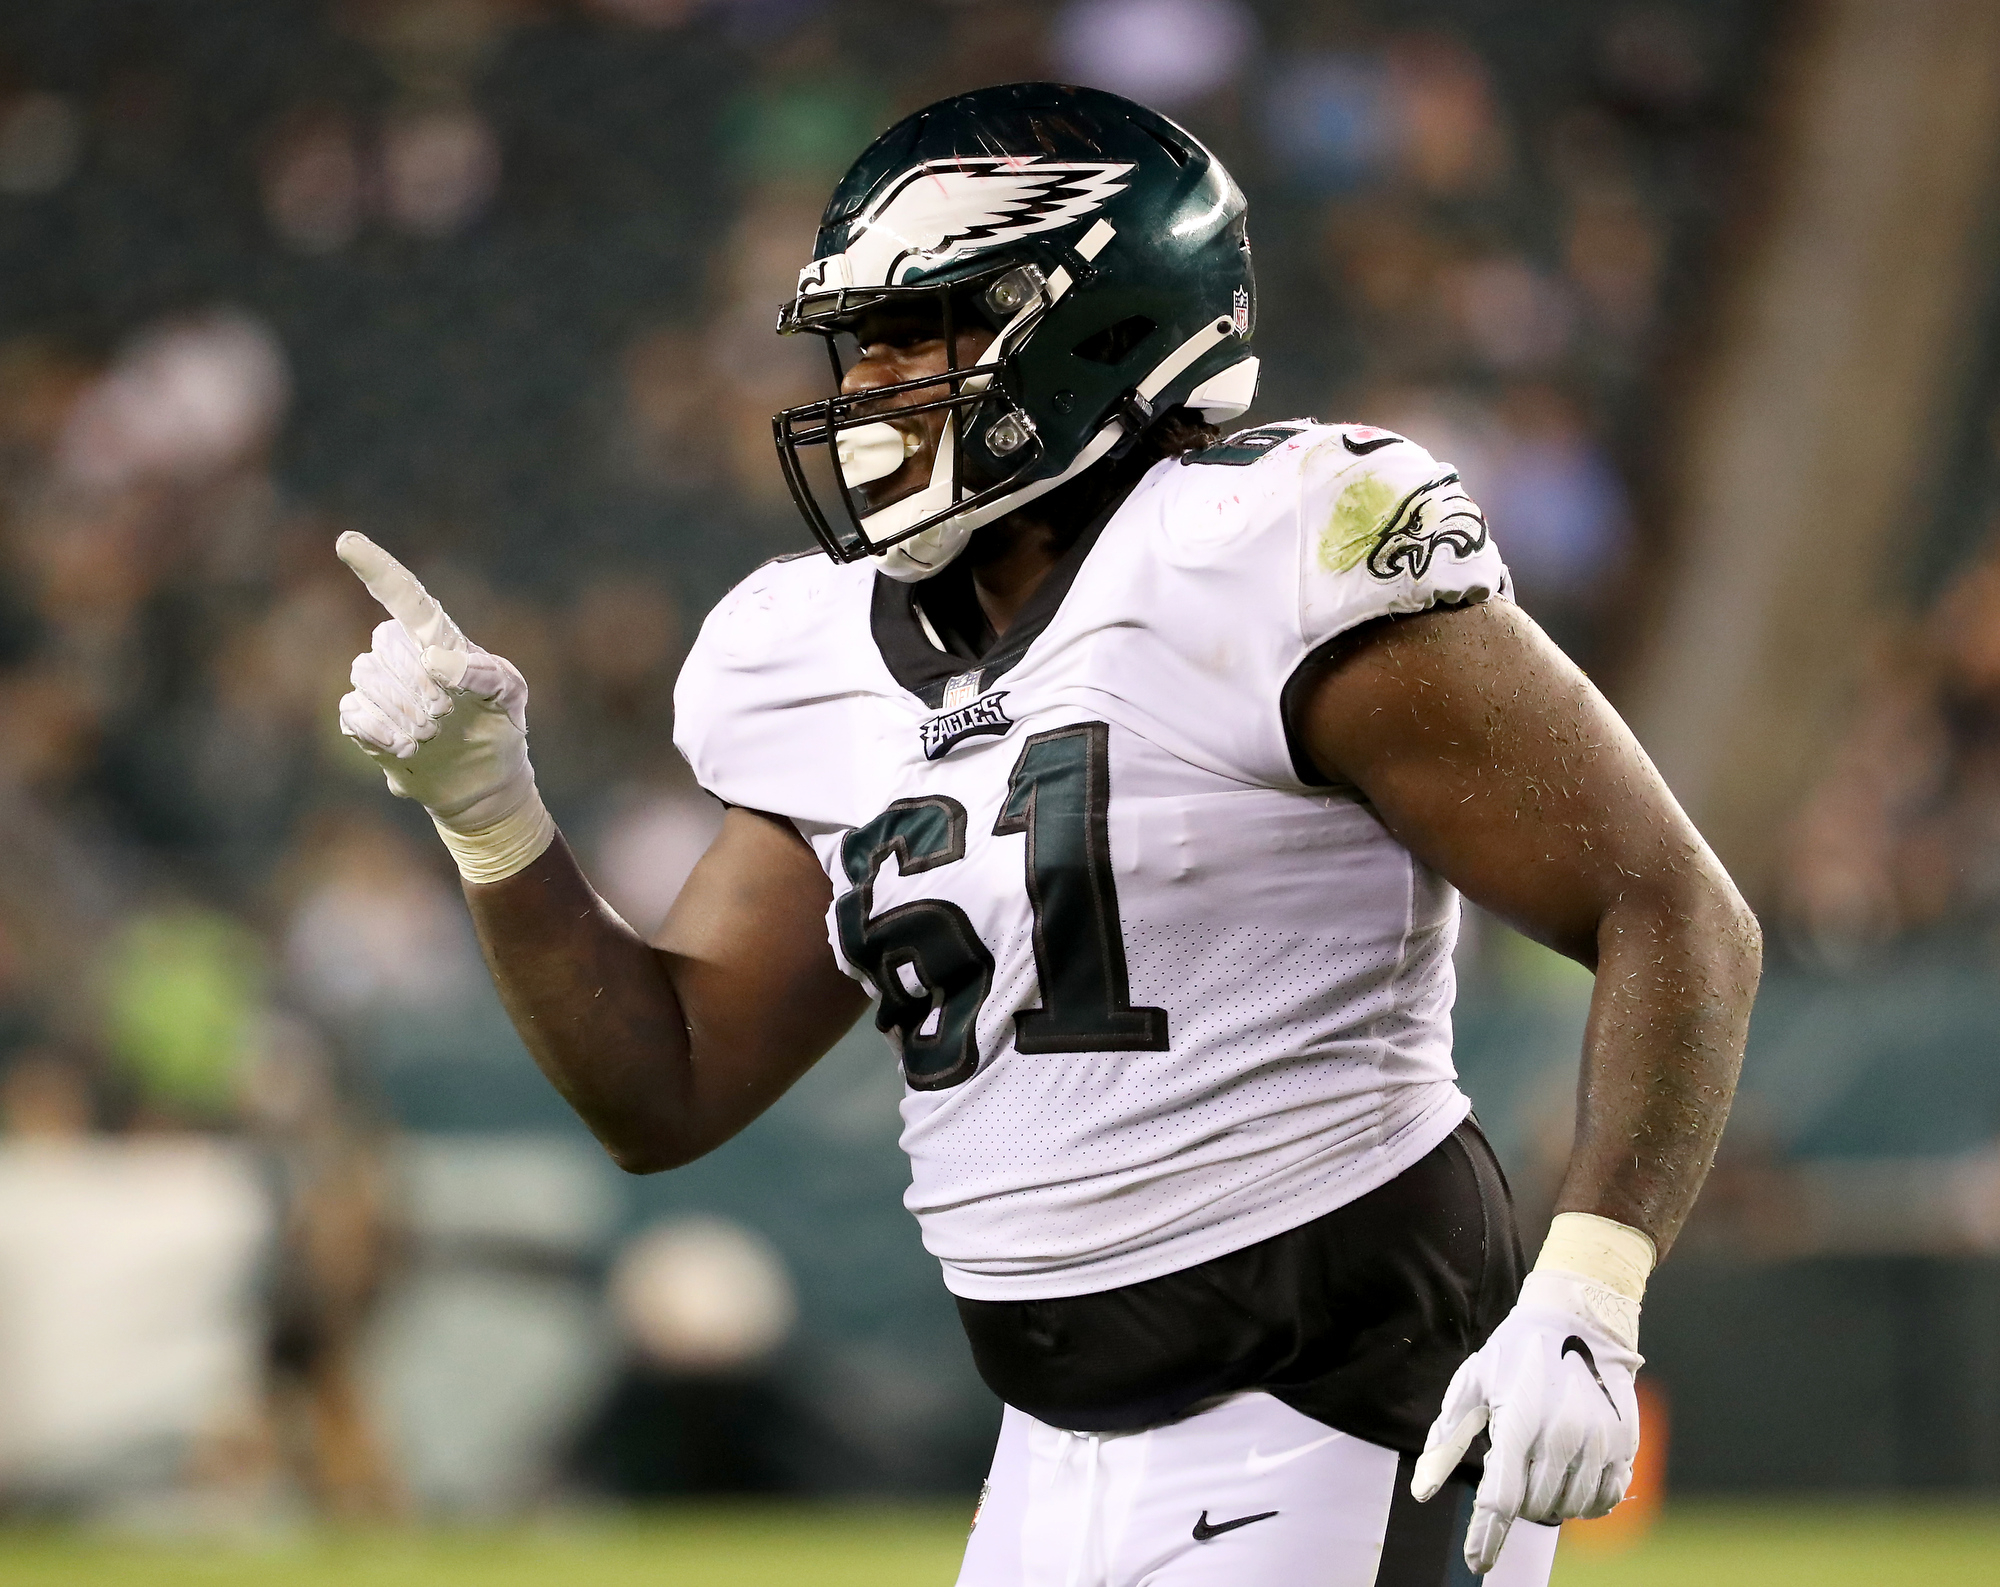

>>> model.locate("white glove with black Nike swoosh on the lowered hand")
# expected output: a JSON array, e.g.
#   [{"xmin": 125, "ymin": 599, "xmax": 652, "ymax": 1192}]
[{"xmin": 1410, "ymin": 1269, "xmax": 1644, "ymax": 1575}]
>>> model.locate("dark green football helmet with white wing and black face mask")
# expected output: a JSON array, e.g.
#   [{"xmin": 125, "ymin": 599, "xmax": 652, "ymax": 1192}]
[{"xmin": 772, "ymin": 82, "xmax": 1258, "ymax": 580}]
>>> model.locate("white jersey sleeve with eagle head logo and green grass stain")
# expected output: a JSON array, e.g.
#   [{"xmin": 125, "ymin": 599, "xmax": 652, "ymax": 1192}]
[{"xmin": 1298, "ymin": 430, "xmax": 1512, "ymax": 652}]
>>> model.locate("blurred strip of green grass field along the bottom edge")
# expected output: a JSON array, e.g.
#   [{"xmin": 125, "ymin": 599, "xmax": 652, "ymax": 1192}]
[{"xmin": 0, "ymin": 1501, "xmax": 2000, "ymax": 1587}]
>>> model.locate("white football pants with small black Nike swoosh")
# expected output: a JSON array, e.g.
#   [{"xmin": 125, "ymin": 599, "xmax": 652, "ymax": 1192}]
[{"xmin": 958, "ymin": 1393, "xmax": 1560, "ymax": 1587}]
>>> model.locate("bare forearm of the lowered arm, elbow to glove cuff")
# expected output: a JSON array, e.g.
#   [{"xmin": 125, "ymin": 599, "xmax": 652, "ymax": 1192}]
[{"xmin": 1556, "ymin": 875, "xmax": 1762, "ymax": 1255}]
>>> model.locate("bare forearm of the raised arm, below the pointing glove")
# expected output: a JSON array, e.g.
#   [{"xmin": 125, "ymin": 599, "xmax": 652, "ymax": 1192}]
[{"xmin": 466, "ymin": 835, "xmax": 688, "ymax": 1167}]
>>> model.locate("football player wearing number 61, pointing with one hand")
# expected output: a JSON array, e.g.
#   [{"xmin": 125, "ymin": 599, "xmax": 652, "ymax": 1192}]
[{"xmin": 340, "ymin": 84, "xmax": 1758, "ymax": 1587}]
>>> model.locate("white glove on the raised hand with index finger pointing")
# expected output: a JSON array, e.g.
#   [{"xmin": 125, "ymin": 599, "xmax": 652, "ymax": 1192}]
[{"xmin": 334, "ymin": 530, "xmax": 556, "ymax": 881}]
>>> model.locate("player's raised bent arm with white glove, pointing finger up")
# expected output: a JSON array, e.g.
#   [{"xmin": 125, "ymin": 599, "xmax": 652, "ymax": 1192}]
[{"xmin": 338, "ymin": 534, "xmax": 866, "ymax": 1173}]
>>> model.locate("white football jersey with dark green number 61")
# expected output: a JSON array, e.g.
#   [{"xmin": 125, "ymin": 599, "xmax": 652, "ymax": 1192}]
[{"xmin": 674, "ymin": 420, "xmax": 1508, "ymax": 1299}]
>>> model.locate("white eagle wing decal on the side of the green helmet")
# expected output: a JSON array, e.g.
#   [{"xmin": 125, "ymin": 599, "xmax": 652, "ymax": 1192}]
[{"xmin": 846, "ymin": 156, "xmax": 1132, "ymax": 286}]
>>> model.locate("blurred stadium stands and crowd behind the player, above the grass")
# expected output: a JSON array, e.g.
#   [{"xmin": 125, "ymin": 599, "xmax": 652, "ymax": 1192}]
[{"xmin": 0, "ymin": 0, "xmax": 2000, "ymax": 1583}]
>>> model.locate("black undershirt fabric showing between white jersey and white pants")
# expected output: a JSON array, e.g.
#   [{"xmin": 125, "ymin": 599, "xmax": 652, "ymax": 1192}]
[{"xmin": 958, "ymin": 1119, "xmax": 1522, "ymax": 1453}]
